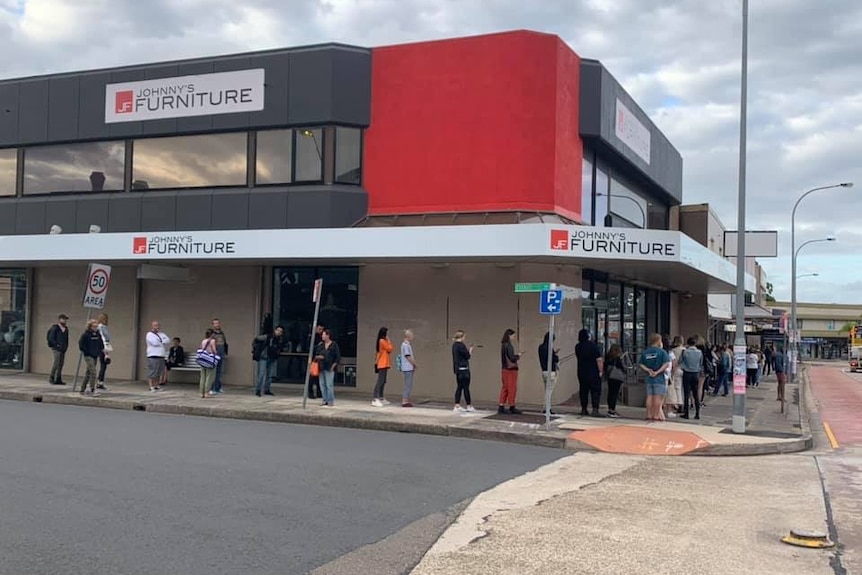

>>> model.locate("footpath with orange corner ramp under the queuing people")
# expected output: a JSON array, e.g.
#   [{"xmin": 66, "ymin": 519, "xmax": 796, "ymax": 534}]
[{"xmin": 0, "ymin": 374, "xmax": 812, "ymax": 455}]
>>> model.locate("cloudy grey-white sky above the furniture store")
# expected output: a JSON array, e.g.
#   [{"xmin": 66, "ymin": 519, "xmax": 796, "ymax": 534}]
[{"xmin": 0, "ymin": 0, "xmax": 862, "ymax": 303}]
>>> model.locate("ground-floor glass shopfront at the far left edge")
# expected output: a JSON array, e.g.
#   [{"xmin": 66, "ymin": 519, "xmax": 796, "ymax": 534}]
[{"xmin": 0, "ymin": 269, "xmax": 27, "ymax": 369}]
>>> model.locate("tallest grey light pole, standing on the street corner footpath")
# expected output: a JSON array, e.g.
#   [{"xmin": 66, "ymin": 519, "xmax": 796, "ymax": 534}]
[{"xmin": 733, "ymin": 0, "xmax": 748, "ymax": 433}]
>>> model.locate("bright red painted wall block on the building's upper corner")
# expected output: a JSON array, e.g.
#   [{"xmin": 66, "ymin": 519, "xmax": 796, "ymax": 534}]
[{"xmin": 364, "ymin": 31, "xmax": 582, "ymax": 220}]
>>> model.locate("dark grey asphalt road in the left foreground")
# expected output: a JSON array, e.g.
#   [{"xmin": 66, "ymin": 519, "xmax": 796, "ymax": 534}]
[{"xmin": 0, "ymin": 401, "xmax": 565, "ymax": 575}]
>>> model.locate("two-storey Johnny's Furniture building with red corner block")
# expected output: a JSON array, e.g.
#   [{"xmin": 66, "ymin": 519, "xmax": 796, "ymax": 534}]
[{"xmin": 0, "ymin": 31, "xmax": 753, "ymax": 402}]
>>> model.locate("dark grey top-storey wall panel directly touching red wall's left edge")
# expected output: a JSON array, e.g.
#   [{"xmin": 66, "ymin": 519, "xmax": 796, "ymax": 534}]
[{"xmin": 331, "ymin": 50, "xmax": 371, "ymax": 126}]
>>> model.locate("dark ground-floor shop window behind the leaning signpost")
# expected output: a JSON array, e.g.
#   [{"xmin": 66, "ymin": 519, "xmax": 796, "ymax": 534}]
[{"xmin": 272, "ymin": 267, "xmax": 359, "ymax": 386}]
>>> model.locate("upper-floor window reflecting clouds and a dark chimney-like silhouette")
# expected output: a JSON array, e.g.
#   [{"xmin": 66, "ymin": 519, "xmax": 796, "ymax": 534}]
[{"xmin": 23, "ymin": 142, "xmax": 126, "ymax": 195}]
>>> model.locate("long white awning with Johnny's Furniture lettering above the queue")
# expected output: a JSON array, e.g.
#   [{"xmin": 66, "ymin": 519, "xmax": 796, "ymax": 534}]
[{"xmin": 0, "ymin": 223, "xmax": 754, "ymax": 293}]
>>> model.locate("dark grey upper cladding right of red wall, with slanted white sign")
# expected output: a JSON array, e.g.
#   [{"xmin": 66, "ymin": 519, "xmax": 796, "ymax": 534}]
[{"xmin": 579, "ymin": 59, "xmax": 682, "ymax": 204}]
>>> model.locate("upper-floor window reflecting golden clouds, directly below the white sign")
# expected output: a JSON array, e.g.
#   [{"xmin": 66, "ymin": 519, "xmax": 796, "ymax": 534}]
[{"xmin": 132, "ymin": 132, "xmax": 248, "ymax": 190}]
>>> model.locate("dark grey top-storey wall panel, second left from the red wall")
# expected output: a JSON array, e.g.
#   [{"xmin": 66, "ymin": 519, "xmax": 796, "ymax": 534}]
[{"xmin": 287, "ymin": 50, "xmax": 332, "ymax": 124}]
